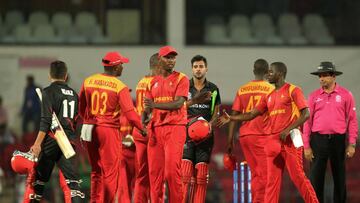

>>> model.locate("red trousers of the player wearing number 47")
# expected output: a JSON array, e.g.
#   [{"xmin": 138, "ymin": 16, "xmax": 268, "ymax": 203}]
[{"xmin": 239, "ymin": 135, "xmax": 268, "ymax": 203}]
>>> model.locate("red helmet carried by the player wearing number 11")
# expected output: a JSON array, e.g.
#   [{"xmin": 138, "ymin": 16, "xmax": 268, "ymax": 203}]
[{"xmin": 11, "ymin": 150, "xmax": 37, "ymax": 174}]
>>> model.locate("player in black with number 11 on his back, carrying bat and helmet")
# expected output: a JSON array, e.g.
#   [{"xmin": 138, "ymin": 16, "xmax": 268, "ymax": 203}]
[{"xmin": 30, "ymin": 61, "xmax": 84, "ymax": 202}]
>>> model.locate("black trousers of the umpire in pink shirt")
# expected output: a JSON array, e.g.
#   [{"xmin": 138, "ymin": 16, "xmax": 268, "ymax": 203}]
[{"xmin": 310, "ymin": 133, "xmax": 346, "ymax": 203}]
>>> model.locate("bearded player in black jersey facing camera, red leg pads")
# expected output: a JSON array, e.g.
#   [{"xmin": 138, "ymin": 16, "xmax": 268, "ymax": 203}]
[{"xmin": 181, "ymin": 55, "xmax": 221, "ymax": 203}]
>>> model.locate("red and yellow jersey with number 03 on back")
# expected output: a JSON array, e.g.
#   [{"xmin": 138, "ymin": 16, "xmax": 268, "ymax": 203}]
[{"xmin": 79, "ymin": 74, "xmax": 134, "ymax": 127}]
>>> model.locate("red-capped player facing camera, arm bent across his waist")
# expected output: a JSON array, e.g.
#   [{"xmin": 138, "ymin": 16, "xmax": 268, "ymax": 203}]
[{"xmin": 143, "ymin": 46, "xmax": 189, "ymax": 203}]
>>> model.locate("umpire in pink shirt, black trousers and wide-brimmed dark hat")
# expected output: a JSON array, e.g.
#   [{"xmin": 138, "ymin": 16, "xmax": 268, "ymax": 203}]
[{"xmin": 303, "ymin": 62, "xmax": 358, "ymax": 203}]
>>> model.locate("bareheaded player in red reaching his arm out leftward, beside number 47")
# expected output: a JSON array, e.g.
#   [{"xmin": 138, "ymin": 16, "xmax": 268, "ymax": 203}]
[{"xmin": 219, "ymin": 62, "xmax": 319, "ymax": 203}]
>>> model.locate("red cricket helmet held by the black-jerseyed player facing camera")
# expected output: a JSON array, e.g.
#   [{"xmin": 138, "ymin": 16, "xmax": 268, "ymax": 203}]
[{"xmin": 187, "ymin": 117, "xmax": 211, "ymax": 142}]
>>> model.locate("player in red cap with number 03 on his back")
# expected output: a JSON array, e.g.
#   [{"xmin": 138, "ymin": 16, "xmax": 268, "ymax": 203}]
[{"xmin": 79, "ymin": 52, "xmax": 142, "ymax": 202}]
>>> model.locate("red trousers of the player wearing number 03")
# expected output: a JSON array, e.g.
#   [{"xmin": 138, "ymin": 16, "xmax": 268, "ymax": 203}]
[{"xmin": 86, "ymin": 126, "xmax": 121, "ymax": 203}]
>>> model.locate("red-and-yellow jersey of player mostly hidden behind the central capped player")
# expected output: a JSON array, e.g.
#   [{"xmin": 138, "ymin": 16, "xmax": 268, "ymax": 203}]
[{"xmin": 136, "ymin": 76, "xmax": 154, "ymax": 115}]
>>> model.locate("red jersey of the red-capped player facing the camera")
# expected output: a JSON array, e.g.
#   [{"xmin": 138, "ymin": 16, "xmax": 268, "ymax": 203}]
[{"xmin": 146, "ymin": 71, "xmax": 190, "ymax": 127}]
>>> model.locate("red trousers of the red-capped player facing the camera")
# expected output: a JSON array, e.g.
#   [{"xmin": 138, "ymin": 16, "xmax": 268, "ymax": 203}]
[{"xmin": 148, "ymin": 125, "xmax": 186, "ymax": 203}]
